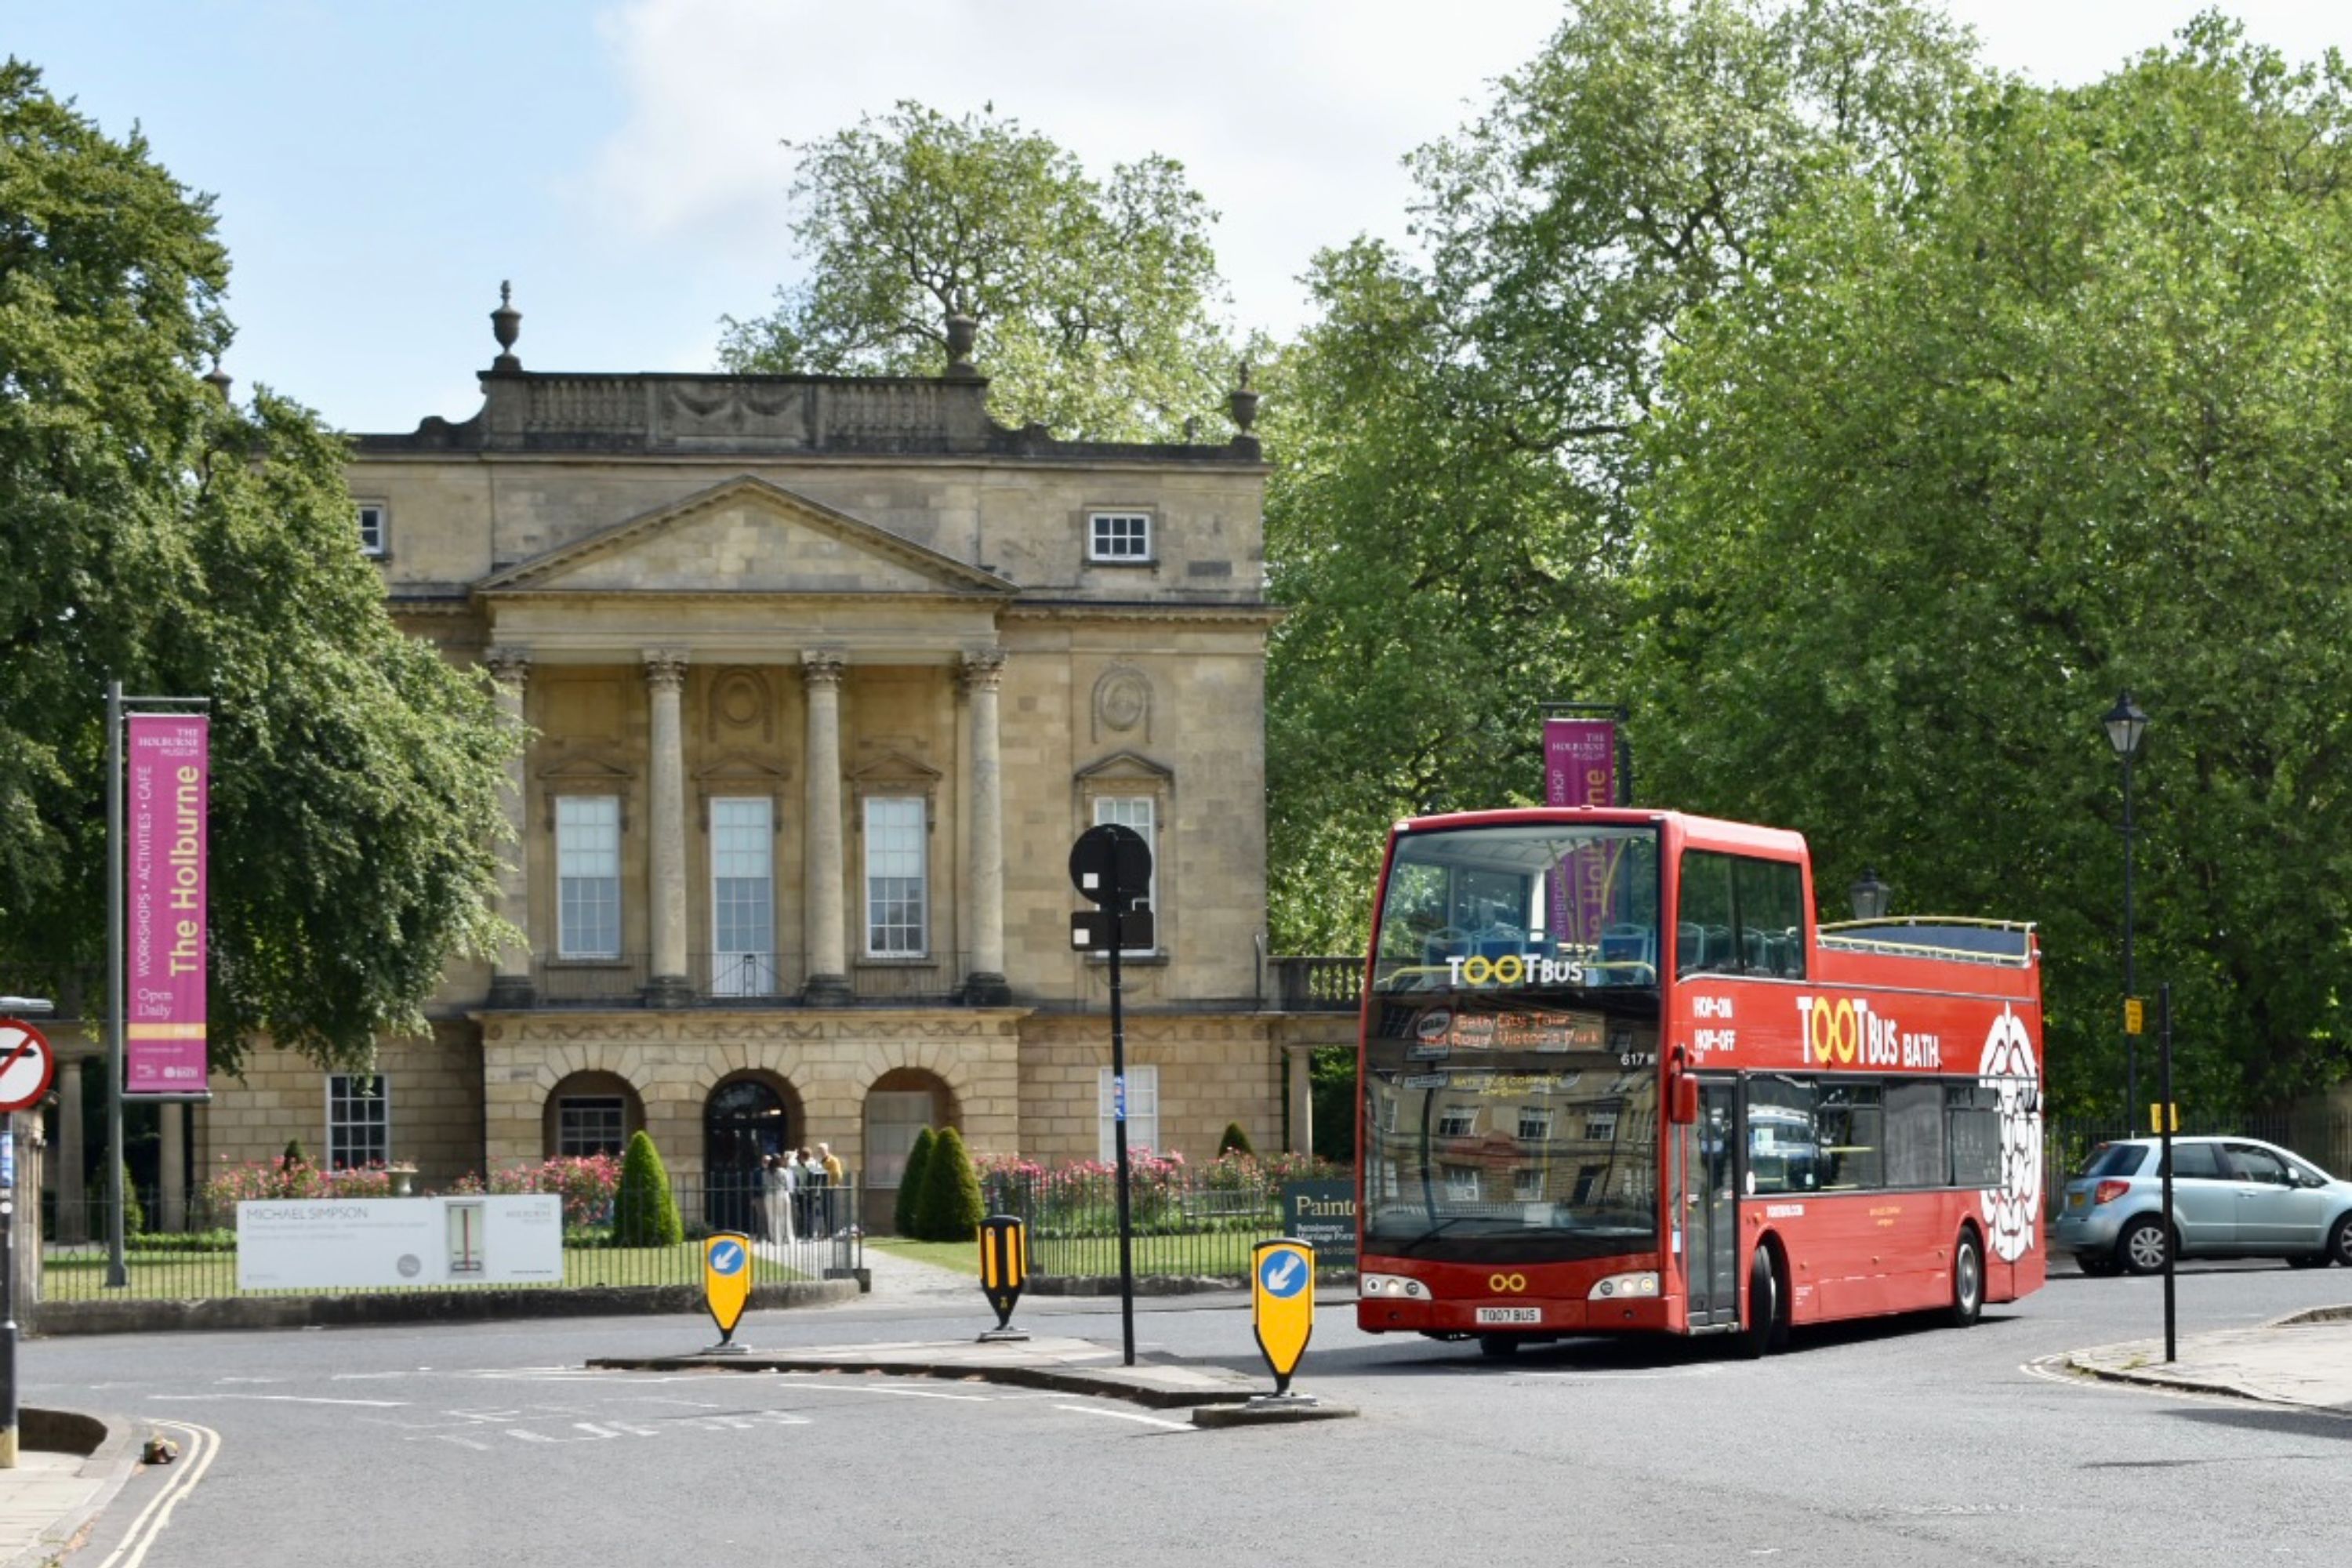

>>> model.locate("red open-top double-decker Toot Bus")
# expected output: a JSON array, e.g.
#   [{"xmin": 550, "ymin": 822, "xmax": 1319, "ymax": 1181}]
[{"xmin": 1357, "ymin": 806, "xmax": 2044, "ymax": 1354}]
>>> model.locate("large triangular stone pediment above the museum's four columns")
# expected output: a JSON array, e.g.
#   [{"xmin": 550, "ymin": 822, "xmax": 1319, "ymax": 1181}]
[{"xmin": 482, "ymin": 475, "xmax": 1016, "ymax": 597}]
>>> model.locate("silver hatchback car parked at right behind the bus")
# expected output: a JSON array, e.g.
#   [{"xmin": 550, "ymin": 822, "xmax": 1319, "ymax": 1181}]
[{"xmin": 2051, "ymin": 1138, "xmax": 2352, "ymax": 1274}]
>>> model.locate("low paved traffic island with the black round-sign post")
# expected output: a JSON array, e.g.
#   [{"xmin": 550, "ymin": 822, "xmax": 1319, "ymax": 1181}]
[{"xmin": 588, "ymin": 1335, "xmax": 1265, "ymax": 1410}]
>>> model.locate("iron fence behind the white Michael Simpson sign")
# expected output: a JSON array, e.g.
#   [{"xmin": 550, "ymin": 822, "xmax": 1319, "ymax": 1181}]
[{"xmin": 40, "ymin": 1175, "xmax": 866, "ymax": 1302}]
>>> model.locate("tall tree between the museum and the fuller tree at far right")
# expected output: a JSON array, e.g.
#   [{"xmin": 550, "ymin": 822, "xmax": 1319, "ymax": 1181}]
[{"xmin": 1265, "ymin": 0, "xmax": 1971, "ymax": 952}]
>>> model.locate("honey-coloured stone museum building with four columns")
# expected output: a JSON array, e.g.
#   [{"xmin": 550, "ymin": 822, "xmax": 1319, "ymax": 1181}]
[{"xmin": 52, "ymin": 308, "xmax": 1352, "ymax": 1220}]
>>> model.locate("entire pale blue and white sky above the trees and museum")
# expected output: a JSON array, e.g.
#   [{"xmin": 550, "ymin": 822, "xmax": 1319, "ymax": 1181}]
[{"xmin": 18, "ymin": 0, "xmax": 2352, "ymax": 433}]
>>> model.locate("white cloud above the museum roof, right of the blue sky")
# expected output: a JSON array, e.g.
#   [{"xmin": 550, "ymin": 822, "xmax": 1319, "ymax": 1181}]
[{"xmin": 588, "ymin": 0, "xmax": 1559, "ymax": 329}]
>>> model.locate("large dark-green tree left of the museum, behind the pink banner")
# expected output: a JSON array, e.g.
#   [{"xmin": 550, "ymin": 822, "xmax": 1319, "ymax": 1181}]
[{"xmin": 0, "ymin": 61, "xmax": 510, "ymax": 1069}]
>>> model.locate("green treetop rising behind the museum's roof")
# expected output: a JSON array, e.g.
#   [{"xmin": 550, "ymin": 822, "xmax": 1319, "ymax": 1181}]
[{"xmin": 720, "ymin": 103, "xmax": 1232, "ymax": 440}]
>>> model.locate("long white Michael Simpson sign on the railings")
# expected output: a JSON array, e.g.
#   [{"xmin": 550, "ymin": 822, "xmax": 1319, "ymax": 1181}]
[{"xmin": 238, "ymin": 1192, "xmax": 564, "ymax": 1290}]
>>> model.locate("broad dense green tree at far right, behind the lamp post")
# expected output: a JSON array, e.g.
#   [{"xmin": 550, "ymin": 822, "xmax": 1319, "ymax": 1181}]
[{"xmin": 1639, "ymin": 16, "xmax": 2352, "ymax": 1112}]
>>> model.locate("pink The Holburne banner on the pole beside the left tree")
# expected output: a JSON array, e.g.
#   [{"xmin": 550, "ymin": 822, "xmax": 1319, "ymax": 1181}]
[{"xmin": 122, "ymin": 713, "xmax": 212, "ymax": 1095}]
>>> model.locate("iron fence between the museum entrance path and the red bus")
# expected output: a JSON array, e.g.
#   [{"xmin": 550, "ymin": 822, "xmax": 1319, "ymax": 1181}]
[{"xmin": 981, "ymin": 1156, "xmax": 1355, "ymax": 1279}]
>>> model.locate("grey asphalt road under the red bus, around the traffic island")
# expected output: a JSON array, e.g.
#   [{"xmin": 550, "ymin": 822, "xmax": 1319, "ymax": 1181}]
[{"xmin": 24, "ymin": 1265, "xmax": 2352, "ymax": 1568}]
